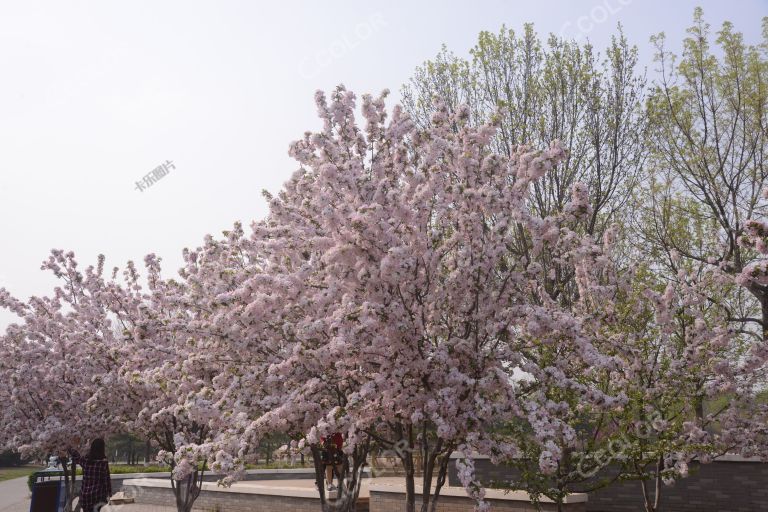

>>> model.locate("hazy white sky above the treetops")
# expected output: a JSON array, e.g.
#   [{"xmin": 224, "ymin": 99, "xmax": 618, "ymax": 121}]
[{"xmin": 0, "ymin": 0, "xmax": 768, "ymax": 327}]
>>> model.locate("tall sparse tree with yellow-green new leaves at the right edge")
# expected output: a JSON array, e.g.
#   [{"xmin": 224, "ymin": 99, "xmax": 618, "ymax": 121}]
[{"xmin": 636, "ymin": 9, "xmax": 768, "ymax": 339}]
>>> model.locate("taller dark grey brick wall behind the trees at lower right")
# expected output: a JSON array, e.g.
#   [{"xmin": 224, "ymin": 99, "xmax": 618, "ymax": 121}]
[{"xmin": 448, "ymin": 459, "xmax": 768, "ymax": 512}]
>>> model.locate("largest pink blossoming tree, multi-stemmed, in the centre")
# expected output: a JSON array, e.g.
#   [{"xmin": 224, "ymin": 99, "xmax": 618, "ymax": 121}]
[{"xmin": 190, "ymin": 87, "xmax": 615, "ymax": 511}]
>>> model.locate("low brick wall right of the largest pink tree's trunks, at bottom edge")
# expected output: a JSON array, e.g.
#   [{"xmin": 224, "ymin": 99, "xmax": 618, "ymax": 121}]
[{"xmin": 368, "ymin": 491, "xmax": 587, "ymax": 512}]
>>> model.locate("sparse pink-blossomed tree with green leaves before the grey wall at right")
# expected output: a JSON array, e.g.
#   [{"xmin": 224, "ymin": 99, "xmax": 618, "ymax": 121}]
[{"xmin": 577, "ymin": 270, "xmax": 740, "ymax": 512}]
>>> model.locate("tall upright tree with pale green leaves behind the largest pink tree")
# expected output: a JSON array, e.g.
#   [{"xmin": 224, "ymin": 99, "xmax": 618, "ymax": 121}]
[{"xmin": 403, "ymin": 24, "xmax": 646, "ymax": 235}]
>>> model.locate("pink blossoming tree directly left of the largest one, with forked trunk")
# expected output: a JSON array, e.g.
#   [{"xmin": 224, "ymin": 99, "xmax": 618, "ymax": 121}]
[{"xmin": 90, "ymin": 224, "xmax": 256, "ymax": 512}]
